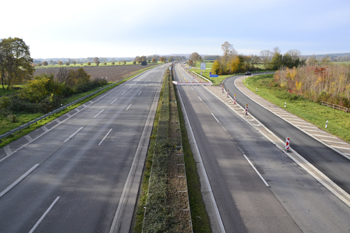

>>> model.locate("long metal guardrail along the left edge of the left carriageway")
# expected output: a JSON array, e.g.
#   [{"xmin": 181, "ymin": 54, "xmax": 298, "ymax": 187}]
[{"xmin": 0, "ymin": 70, "xmax": 148, "ymax": 141}]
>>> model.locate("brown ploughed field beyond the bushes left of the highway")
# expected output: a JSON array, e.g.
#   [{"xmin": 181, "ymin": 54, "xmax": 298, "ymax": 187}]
[{"xmin": 34, "ymin": 65, "xmax": 157, "ymax": 82}]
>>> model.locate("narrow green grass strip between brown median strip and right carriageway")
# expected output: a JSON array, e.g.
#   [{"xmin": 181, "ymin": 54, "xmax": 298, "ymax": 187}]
[{"xmin": 175, "ymin": 85, "xmax": 212, "ymax": 233}]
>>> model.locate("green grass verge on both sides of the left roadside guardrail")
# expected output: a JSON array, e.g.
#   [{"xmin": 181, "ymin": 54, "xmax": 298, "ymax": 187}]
[{"xmin": 0, "ymin": 67, "xmax": 154, "ymax": 148}]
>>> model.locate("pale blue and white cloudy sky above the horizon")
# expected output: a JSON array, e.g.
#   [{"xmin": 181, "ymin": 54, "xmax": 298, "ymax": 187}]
[{"xmin": 0, "ymin": 0, "xmax": 350, "ymax": 58}]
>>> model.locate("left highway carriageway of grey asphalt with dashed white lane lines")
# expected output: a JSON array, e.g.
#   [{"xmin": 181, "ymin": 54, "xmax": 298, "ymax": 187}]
[{"xmin": 0, "ymin": 66, "xmax": 167, "ymax": 233}]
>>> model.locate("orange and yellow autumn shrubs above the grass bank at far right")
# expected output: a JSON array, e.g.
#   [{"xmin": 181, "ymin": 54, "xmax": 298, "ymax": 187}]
[{"xmin": 274, "ymin": 64, "xmax": 350, "ymax": 108}]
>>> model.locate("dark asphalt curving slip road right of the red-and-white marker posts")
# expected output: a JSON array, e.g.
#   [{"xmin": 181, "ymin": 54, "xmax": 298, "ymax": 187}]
[{"xmin": 224, "ymin": 76, "xmax": 350, "ymax": 193}]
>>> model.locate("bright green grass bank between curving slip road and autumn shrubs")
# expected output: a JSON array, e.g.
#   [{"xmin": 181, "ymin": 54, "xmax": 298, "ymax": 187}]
[{"xmin": 244, "ymin": 74, "xmax": 350, "ymax": 142}]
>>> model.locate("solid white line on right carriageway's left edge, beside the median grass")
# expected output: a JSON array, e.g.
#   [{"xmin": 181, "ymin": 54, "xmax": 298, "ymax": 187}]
[{"xmin": 178, "ymin": 83, "xmax": 226, "ymax": 232}]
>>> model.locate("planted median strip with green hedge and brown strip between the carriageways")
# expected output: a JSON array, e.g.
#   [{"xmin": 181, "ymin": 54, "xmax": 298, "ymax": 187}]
[{"xmin": 134, "ymin": 68, "xmax": 192, "ymax": 232}]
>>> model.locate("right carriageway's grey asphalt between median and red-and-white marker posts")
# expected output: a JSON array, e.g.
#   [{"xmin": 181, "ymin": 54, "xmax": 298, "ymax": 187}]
[{"xmin": 175, "ymin": 65, "xmax": 350, "ymax": 232}]
